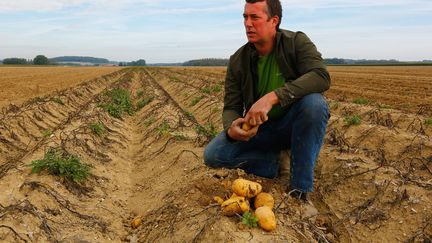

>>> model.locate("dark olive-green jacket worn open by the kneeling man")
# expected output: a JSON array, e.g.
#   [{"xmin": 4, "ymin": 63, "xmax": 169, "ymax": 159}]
[{"xmin": 223, "ymin": 30, "xmax": 330, "ymax": 129}]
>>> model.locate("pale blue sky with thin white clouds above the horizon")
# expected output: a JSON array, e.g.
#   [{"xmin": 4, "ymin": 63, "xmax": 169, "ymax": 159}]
[{"xmin": 0, "ymin": 0, "xmax": 432, "ymax": 63}]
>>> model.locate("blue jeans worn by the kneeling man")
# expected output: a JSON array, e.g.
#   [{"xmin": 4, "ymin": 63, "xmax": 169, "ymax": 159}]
[{"xmin": 204, "ymin": 93, "xmax": 329, "ymax": 192}]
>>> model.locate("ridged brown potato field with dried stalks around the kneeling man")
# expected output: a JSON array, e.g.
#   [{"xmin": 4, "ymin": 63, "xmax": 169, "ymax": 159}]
[{"xmin": 0, "ymin": 67, "xmax": 432, "ymax": 242}]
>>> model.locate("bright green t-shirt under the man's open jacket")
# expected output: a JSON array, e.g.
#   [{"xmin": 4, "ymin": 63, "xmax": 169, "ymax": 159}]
[{"xmin": 255, "ymin": 52, "xmax": 286, "ymax": 120}]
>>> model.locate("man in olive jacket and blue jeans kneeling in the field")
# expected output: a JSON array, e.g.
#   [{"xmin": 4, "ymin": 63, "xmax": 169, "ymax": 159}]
[{"xmin": 204, "ymin": 0, "xmax": 330, "ymax": 200}]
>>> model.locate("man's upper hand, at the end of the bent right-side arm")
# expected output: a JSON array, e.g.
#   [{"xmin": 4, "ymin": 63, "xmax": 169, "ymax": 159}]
[{"xmin": 244, "ymin": 91, "xmax": 279, "ymax": 126}]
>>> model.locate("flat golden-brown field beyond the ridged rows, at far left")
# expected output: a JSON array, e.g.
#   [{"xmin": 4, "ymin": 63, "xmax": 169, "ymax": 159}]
[{"xmin": 0, "ymin": 67, "xmax": 121, "ymax": 108}]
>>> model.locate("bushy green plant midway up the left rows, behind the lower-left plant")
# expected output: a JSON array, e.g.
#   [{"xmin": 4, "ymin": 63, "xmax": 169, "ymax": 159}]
[{"xmin": 100, "ymin": 89, "xmax": 134, "ymax": 118}]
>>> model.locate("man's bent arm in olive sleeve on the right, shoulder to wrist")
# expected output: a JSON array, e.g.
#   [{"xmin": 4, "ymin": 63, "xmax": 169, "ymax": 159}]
[{"xmin": 275, "ymin": 32, "xmax": 331, "ymax": 107}]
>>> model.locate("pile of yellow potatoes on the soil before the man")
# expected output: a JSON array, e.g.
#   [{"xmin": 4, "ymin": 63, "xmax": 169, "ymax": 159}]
[{"xmin": 214, "ymin": 178, "xmax": 276, "ymax": 231}]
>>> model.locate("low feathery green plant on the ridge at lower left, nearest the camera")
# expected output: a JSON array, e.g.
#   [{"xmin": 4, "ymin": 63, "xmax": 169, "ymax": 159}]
[{"xmin": 28, "ymin": 149, "xmax": 91, "ymax": 182}]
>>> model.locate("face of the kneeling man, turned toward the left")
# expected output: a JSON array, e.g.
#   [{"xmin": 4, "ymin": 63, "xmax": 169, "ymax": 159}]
[{"xmin": 243, "ymin": 1, "xmax": 279, "ymax": 44}]
